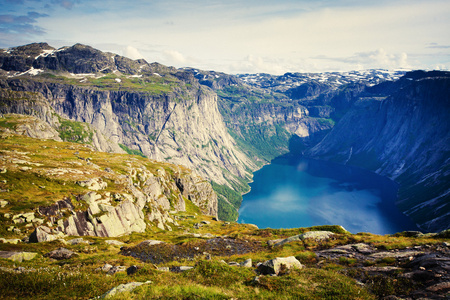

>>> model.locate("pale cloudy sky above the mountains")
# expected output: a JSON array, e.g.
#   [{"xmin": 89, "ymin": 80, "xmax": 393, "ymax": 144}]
[{"xmin": 0, "ymin": 0, "xmax": 450, "ymax": 74}]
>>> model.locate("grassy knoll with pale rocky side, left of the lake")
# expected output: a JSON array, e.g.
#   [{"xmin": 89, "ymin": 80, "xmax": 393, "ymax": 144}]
[{"xmin": 0, "ymin": 114, "xmax": 218, "ymax": 242}]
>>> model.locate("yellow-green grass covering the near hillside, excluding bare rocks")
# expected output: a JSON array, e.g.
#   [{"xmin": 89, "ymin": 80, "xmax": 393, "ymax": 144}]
[{"xmin": 0, "ymin": 116, "xmax": 442, "ymax": 299}]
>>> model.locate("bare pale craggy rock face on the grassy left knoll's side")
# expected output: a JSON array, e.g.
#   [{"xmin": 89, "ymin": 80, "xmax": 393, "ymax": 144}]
[{"xmin": 25, "ymin": 166, "xmax": 217, "ymax": 242}]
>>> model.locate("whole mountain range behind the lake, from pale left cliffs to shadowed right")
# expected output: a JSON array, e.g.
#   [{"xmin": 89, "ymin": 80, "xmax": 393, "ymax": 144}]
[{"xmin": 0, "ymin": 43, "xmax": 450, "ymax": 232}]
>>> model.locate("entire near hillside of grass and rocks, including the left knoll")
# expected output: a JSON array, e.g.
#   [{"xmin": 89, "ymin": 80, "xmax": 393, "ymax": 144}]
[{"xmin": 0, "ymin": 123, "xmax": 450, "ymax": 299}]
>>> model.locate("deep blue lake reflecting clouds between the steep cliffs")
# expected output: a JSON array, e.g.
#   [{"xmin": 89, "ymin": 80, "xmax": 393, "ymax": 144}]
[{"xmin": 238, "ymin": 155, "xmax": 418, "ymax": 234}]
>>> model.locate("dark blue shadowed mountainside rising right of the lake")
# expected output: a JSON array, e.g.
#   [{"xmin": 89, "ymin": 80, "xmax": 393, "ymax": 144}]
[{"xmin": 306, "ymin": 72, "xmax": 450, "ymax": 231}]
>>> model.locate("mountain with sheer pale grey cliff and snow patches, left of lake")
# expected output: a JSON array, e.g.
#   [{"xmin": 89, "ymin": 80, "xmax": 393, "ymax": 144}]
[{"xmin": 0, "ymin": 44, "xmax": 256, "ymax": 218}]
